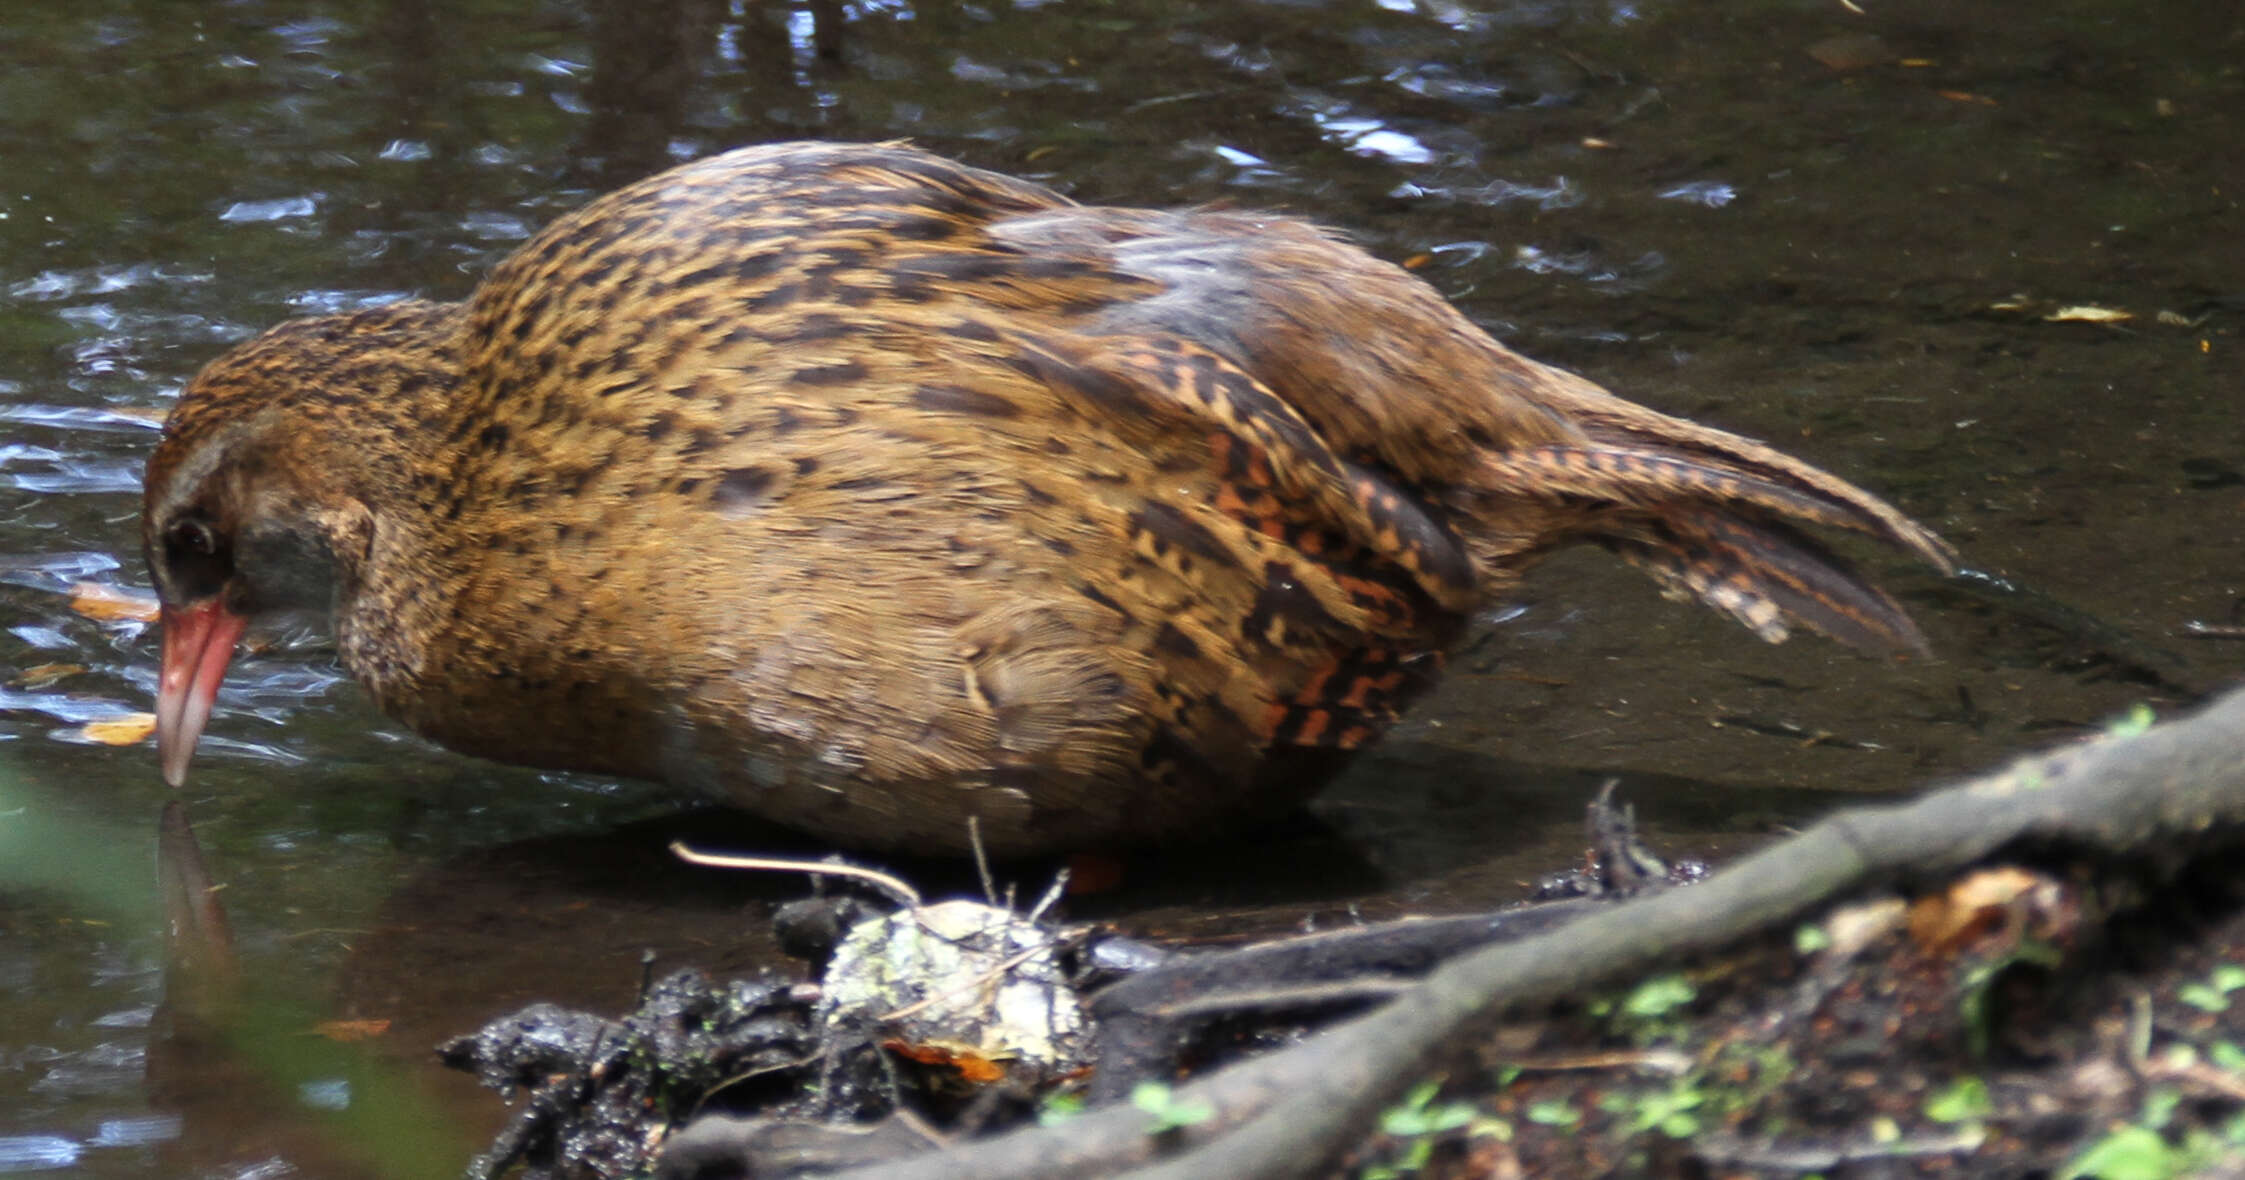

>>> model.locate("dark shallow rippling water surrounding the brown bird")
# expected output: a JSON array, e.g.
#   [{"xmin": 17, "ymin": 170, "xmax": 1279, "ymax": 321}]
[{"xmin": 0, "ymin": 0, "xmax": 2245, "ymax": 1176}]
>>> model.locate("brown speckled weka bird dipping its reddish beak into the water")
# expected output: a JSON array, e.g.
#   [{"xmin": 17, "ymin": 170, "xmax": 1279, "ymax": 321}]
[{"xmin": 144, "ymin": 144, "xmax": 1951, "ymax": 852}]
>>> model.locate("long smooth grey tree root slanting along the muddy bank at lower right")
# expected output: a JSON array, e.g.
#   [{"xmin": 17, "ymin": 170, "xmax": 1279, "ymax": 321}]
[{"xmin": 665, "ymin": 691, "xmax": 2245, "ymax": 1180}]
